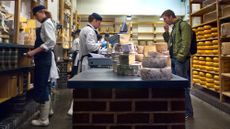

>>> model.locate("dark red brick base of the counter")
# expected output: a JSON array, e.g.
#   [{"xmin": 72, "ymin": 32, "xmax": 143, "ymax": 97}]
[{"xmin": 73, "ymin": 88, "xmax": 185, "ymax": 129}]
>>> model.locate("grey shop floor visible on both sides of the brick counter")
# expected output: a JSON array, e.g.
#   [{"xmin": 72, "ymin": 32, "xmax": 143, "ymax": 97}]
[{"xmin": 21, "ymin": 90, "xmax": 230, "ymax": 129}]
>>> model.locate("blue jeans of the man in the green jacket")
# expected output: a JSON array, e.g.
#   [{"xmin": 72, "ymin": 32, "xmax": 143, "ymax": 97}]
[{"xmin": 171, "ymin": 58, "xmax": 193, "ymax": 116}]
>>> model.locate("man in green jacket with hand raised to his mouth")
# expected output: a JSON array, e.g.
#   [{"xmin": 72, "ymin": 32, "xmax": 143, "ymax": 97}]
[{"xmin": 161, "ymin": 10, "xmax": 193, "ymax": 118}]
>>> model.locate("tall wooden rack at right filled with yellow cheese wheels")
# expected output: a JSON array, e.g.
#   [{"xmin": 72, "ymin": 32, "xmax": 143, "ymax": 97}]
[{"xmin": 190, "ymin": 0, "xmax": 230, "ymax": 101}]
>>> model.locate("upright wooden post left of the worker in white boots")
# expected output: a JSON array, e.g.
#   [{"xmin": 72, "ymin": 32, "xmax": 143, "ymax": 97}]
[{"xmin": 14, "ymin": 0, "xmax": 21, "ymax": 43}]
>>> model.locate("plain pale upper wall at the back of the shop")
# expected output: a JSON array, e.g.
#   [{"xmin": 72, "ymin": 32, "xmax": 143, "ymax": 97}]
[{"xmin": 77, "ymin": 0, "xmax": 185, "ymax": 15}]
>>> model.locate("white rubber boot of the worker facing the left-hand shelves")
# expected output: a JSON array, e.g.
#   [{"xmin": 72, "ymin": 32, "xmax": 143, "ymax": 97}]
[{"xmin": 31, "ymin": 100, "xmax": 50, "ymax": 127}]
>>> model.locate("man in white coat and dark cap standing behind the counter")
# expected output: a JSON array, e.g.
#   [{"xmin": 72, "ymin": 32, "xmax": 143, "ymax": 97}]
[{"xmin": 78, "ymin": 13, "xmax": 102, "ymax": 72}]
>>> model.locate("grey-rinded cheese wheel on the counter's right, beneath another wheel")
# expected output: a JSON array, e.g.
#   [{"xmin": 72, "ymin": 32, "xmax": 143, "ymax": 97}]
[{"xmin": 140, "ymin": 67, "xmax": 172, "ymax": 80}]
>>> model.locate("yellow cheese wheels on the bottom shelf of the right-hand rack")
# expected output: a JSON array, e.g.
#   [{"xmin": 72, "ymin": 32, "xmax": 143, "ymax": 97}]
[{"xmin": 192, "ymin": 70, "xmax": 220, "ymax": 92}]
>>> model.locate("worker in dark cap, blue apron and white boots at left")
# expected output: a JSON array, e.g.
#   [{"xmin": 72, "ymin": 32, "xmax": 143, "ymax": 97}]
[{"xmin": 27, "ymin": 5, "xmax": 58, "ymax": 126}]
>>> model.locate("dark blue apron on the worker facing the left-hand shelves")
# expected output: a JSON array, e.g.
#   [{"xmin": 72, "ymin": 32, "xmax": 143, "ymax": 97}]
[{"xmin": 33, "ymin": 28, "xmax": 52, "ymax": 103}]
